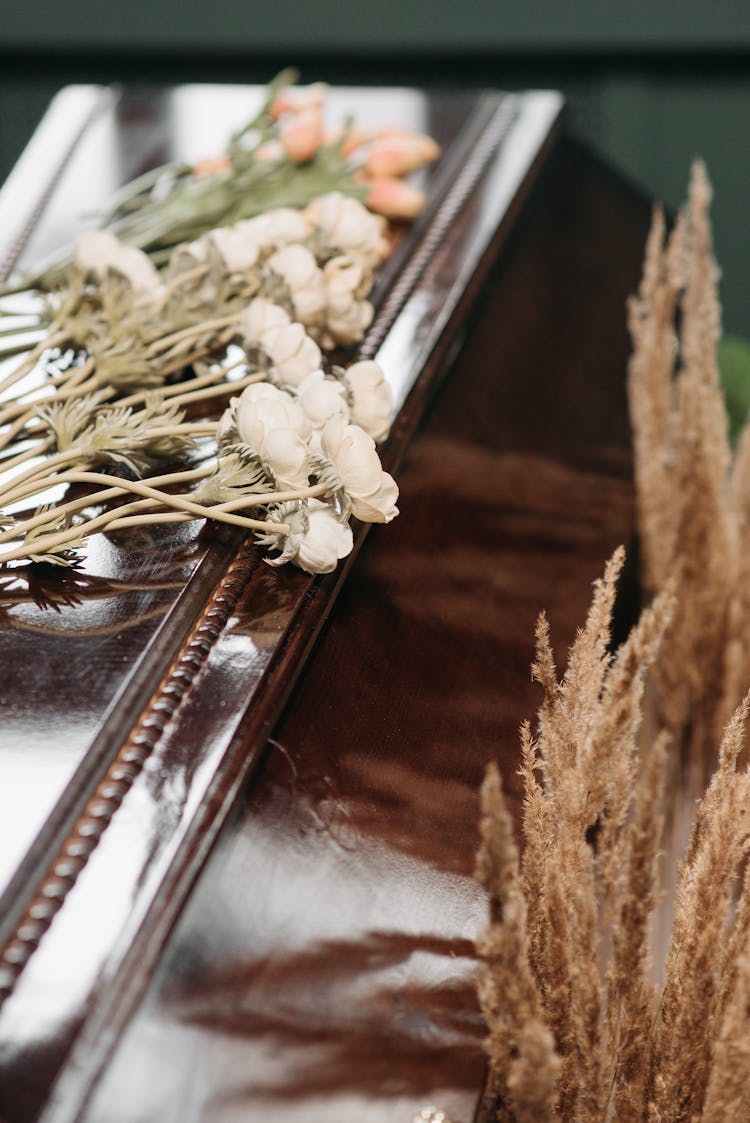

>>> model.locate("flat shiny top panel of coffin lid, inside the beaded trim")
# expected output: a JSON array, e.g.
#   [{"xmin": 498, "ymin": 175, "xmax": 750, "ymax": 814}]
[{"xmin": 0, "ymin": 86, "xmax": 486, "ymax": 929}]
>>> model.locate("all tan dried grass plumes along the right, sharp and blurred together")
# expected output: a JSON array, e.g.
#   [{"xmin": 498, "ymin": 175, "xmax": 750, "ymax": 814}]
[{"xmin": 477, "ymin": 164, "xmax": 750, "ymax": 1123}]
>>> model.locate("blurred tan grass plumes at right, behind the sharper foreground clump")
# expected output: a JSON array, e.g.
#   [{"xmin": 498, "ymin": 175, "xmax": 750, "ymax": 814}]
[{"xmin": 629, "ymin": 162, "xmax": 750, "ymax": 760}]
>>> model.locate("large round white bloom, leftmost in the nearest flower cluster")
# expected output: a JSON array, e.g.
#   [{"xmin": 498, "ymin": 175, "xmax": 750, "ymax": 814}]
[{"xmin": 230, "ymin": 382, "xmax": 310, "ymax": 490}]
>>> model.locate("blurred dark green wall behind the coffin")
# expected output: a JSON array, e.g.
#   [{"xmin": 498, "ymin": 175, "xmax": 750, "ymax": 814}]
[{"xmin": 0, "ymin": 0, "xmax": 750, "ymax": 338}]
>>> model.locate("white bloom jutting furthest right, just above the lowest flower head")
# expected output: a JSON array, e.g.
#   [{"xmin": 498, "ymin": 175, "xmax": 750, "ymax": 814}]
[{"xmin": 321, "ymin": 417, "xmax": 399, "ymax": 522}]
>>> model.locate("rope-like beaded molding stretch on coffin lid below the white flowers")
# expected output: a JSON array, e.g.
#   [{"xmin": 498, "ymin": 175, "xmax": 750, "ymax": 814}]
[{"xmin": 0, "ymin": 545, "xmax": 257, "ymax": 1004}]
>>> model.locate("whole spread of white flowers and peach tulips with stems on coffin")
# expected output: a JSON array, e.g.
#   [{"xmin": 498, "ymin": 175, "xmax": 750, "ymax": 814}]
[{"xmin": 0, "ymin": 72, "xmax": 439, "ymax": 573}]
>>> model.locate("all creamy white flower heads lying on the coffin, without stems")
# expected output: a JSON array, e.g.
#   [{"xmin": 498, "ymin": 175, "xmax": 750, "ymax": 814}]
[{"xmin": 71, "ymin": 194, "xmax": 399, "ymax": 573}]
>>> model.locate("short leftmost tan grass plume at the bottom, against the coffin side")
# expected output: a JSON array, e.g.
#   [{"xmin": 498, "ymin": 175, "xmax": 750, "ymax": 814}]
[{"xmin": 476, "ymin": 765, "xmax": 559, "ymax": 1123}]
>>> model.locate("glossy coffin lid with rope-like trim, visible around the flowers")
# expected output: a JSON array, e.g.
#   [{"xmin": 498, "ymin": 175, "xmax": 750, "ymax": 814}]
[{"xmin": 0, "ymin": 81, "xmax": 560, "ymax": 1121}]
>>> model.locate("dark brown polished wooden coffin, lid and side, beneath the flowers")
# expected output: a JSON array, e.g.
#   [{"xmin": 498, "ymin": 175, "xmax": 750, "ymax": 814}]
[{"xmin": 0, "ymin": 81, "xmax": 648, "ymax": 1123}]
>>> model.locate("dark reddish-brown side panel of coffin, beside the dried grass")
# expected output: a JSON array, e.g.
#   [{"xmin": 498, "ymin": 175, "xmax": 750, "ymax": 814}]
[{"xmin": 76, "ymin": 133, "xmax": 648, "ymax": 1123}]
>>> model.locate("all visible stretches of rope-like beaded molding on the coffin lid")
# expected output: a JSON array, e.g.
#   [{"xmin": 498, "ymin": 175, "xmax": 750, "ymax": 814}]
[{"xmin": 0, "ymin": 94, "xmax": 527, "ymax": 1005}]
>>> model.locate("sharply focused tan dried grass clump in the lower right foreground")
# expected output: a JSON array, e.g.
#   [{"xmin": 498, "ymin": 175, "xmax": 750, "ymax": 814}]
[{"xmin": 477, "ymin": 551, "xmax": 750, "ymax": 1123}]
